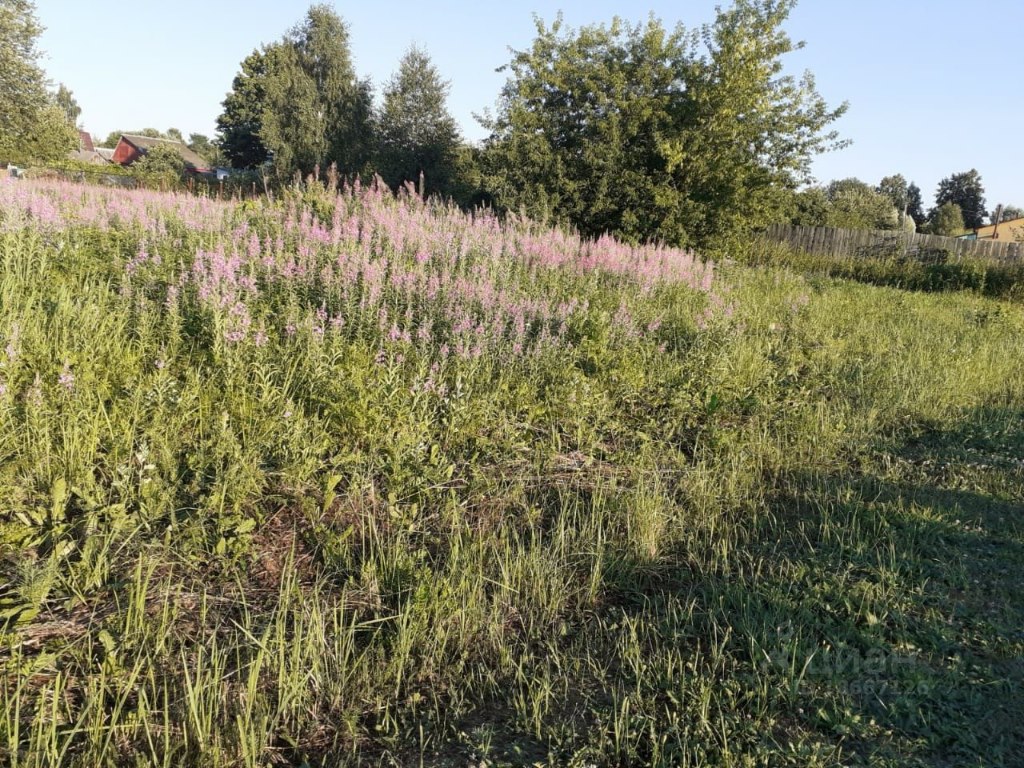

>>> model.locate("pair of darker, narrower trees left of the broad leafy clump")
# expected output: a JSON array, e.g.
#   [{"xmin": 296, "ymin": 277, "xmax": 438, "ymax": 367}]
[{"xmin": 217, "ymin": 5, "xmax": 465, "ymax": 196}]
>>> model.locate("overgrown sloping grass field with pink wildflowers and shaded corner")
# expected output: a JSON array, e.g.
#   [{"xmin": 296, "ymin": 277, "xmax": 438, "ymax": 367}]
[{"xmin": 0, "ymin": 181, "xmax": 1024, "ymax": 768}]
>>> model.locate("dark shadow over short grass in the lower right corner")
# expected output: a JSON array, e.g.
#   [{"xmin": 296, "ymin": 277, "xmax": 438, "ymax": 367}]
[{"xmin": 585, "ymin": 409, "xmax": 1024, "ymax": 766}]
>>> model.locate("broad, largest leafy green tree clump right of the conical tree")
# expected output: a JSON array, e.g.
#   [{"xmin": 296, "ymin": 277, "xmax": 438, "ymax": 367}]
[{"xmin": 484, "ymin": 0, "xmax": 845, "ymax": 245}]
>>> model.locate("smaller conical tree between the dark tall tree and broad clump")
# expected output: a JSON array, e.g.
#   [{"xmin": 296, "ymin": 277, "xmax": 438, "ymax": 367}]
[{"xmin": 376, "ymin": 47, "xmax": 461, "ymax": 195}]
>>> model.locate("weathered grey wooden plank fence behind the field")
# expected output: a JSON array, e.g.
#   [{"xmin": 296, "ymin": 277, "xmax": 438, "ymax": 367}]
[{"xmin": 765, "ymin": 224, "xmax": 1024, "ymax": 264}]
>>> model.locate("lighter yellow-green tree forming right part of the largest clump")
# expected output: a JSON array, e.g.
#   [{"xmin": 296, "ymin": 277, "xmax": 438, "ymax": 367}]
[{"xmin": 670, "ymin": 0, "xmax": 847, "ymax": 244}]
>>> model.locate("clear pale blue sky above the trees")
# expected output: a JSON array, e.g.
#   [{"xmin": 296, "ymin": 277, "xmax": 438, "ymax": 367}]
[{"xmin": 36, "ymin": 0, "xmax": 1024, "ymax": 208}]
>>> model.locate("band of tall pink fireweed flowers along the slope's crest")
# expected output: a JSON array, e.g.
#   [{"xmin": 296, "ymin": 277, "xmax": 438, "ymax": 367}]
[{"xmin": 0, "ymin": 176, "xmax": 731, "ymax": 368}]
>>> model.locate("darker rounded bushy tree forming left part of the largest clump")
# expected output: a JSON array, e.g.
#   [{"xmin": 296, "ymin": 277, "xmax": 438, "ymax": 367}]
[{"xmin": 483, "ymin": 17, "xmax": 687, "ymax": 242}]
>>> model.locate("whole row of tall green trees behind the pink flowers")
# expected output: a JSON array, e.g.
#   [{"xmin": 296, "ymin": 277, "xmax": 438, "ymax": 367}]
[{"xmin": 218, "ymin": 0, "xmax": 845, "ymax": 245}]
